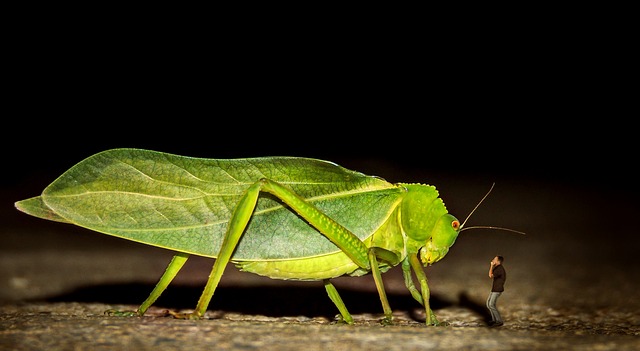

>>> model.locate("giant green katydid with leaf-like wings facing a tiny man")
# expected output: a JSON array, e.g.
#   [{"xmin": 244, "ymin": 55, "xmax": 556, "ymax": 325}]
[{"xmin": 15, "ymin": 149, "xmax": 520, "ymax": 325}]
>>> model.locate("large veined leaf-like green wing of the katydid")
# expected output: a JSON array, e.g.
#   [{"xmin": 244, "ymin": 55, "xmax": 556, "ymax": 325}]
[{"xmin": 16, "ymin": 149, "xmax": 402, "ymax": 261}]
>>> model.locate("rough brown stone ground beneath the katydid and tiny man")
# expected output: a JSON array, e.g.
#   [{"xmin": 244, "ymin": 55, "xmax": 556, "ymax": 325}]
[{"xmin": 0, "ymin": 176, "xmax": 640, "ymax": 351}]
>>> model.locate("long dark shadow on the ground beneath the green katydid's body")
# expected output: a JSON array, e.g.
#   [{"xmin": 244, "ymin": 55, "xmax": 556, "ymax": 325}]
[{"xmin": 40, "ymin": 284, "xmax": 470, "ymax": 322}]
